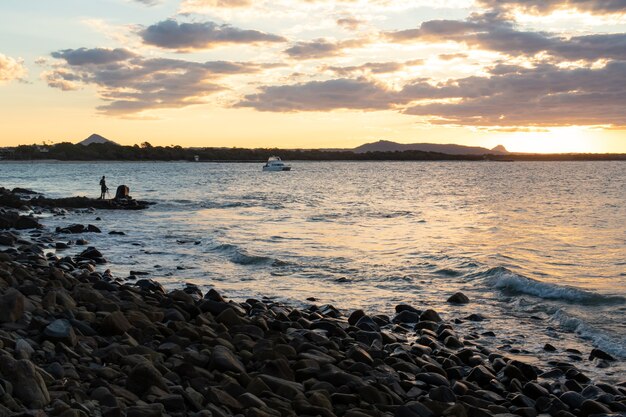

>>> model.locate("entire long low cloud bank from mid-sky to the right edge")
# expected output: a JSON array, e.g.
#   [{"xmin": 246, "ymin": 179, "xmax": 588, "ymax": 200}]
[{"xmin": 237, "ymin": 62, "xmax": 626, "ymax": 128}]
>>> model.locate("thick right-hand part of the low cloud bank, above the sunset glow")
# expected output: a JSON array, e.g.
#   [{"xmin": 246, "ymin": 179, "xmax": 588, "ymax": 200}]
[{"xmin": 400, "ymin": 62, "xmax": 626, "ymax": 126}]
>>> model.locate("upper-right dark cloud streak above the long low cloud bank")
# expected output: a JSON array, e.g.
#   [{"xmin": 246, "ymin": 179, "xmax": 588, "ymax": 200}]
[{"xmin": 384, "ymin": 13, "xmax": 626, "ymax": 61}]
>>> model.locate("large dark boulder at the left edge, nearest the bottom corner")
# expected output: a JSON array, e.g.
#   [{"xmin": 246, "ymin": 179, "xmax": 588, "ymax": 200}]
[{"xmin": 0, "ymin": 356, "xmax": 50, "ymax": 409}]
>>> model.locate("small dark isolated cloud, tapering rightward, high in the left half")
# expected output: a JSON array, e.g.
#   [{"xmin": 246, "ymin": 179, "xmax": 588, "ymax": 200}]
[{"xmin": 139, "ymin": 19, "xmax": 286, "ymax": 51}]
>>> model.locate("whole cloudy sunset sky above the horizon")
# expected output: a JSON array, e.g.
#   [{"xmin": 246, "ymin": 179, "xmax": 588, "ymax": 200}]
[{"xmin": 0, "ymin": 0, "xmax": 626, "ymax": 153}]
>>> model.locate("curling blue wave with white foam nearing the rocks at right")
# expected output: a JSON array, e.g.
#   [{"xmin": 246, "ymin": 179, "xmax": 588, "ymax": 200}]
[{"xmin": 475, "ymin": 267, "xmax": 626, "ymax": 305}]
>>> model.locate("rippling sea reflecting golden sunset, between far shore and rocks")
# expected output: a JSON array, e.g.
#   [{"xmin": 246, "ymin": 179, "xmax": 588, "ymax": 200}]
[{"xmin": 0, "ymin": 161, "xmax": 626, "ymax": 380}]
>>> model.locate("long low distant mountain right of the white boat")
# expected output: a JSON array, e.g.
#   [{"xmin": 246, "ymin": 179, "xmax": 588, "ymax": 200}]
[{"xmin": 352, "ymin": 140, "xmax": 509, "ymax": 155}]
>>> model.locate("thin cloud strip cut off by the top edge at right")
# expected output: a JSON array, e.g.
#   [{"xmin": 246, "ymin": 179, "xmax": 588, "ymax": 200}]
[{"xmin": 478, "ymin": 0, "xmax": 626, "ymax": 14}]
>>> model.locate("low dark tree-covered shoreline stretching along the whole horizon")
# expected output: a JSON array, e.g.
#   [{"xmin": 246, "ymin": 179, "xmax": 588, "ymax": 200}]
[{"xmin": 0, "ymin": 142, "xmax": 626, "ymax": 162}]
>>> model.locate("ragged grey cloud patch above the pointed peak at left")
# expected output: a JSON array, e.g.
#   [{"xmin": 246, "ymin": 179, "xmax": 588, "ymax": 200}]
[{"xmin": 44, "ymin": 48, "xmax": 271, "ymax": 115}]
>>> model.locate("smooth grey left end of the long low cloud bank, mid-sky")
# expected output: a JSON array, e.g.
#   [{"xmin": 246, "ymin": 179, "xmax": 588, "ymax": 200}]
[{"xmin": 236, "ymin": 78, "xmax": 394, "ymax": 112}]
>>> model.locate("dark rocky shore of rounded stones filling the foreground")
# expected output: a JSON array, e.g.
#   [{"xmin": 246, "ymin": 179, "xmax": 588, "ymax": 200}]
[{"xmin": 0, "ymin": 188, "xmax": 626, "ymax": 417}]
